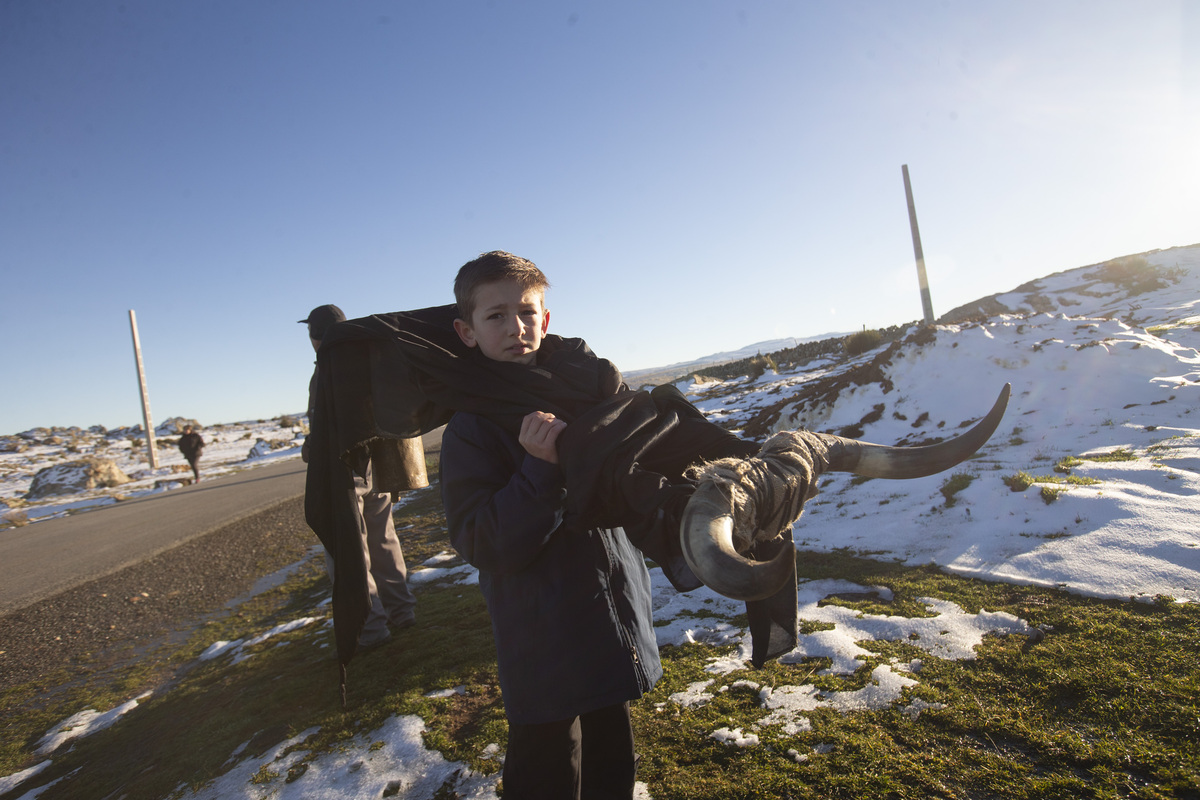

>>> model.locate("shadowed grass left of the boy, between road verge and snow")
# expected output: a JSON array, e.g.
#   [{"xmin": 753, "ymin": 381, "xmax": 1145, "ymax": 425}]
[{"xmin": 12, "ymin": 563, "xmax": 500, "ymax": 798}]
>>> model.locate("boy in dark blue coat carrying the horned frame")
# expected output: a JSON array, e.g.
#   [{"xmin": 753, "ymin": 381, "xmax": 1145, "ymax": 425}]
[{"xmin": 442, "ymin": 252, "xmax": 662, "ymax": 799}]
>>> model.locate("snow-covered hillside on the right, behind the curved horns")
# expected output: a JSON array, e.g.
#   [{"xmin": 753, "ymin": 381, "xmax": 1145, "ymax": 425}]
[{"xmin": 680, "ymin": 246, "xmax": 1200, "ymax": 600}]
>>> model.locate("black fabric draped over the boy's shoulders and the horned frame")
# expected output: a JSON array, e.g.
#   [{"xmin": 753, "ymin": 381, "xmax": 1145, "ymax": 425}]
[{"xmin": 305, "ymin": 305, "xmax": 796, "ymax": 695}]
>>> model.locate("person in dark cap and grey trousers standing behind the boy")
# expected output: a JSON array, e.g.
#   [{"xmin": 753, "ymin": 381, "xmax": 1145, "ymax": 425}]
[{"xmin": 300, "ymin": 305, "xmax": 416, "ymax": 648}]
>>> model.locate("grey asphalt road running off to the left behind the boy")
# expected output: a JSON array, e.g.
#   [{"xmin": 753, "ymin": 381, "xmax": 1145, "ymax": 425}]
[{"xmin": 0, "ymin": 458, "xmax": 307, "ymax": 614}]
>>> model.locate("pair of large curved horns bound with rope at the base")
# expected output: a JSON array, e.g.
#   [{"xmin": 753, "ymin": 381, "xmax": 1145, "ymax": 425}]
[{"xmin": 679, "ymin": 384, "xmax": 1012, "ymax": 601}]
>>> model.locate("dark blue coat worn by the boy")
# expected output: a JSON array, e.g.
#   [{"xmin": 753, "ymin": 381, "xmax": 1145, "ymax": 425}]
[{"xmin": 442, "ymin": 413, "xmax": 662, "ymax": 724}]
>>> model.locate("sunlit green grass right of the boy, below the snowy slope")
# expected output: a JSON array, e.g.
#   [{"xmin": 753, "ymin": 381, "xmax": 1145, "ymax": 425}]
[{"xmin": 635, "ymin": 554, "xmax": 1200, "ymax": 800}]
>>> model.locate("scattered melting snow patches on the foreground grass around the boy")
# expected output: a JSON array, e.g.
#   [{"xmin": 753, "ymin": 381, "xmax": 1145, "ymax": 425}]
[{"xmin": 7, "ymin": 558, "xmax": 1051, "ymax": 800}]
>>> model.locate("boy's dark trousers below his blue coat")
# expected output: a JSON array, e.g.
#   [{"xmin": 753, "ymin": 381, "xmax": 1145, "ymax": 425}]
[{"xmin": 504, "ymin": 703, "xmax": 637, "ymax": 800}]
